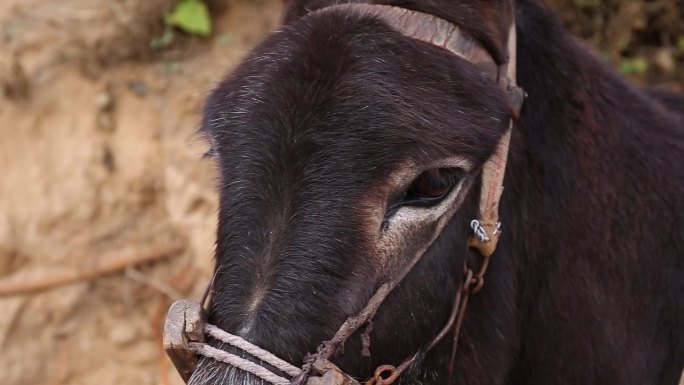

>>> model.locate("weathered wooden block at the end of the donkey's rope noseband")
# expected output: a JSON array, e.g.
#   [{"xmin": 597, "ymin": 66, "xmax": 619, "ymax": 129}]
[{"xmin": 164, "ymin": 299, "xmax": 206, "ymax": 383}]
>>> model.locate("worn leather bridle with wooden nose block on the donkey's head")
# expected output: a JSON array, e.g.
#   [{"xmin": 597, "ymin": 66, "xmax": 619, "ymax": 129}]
[{"xmin": 164, "ymin": 4, "xmax": 524, "ymax": 385}]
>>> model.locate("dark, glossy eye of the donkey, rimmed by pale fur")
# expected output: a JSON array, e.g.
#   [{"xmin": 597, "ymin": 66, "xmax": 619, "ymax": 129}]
[{"xmin": 400, "ymin": 168, "xmax": 463, "ymax": 206}]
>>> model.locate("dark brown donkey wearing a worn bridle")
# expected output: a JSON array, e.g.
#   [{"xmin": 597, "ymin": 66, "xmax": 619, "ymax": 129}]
[{"xmin": 184, "ymin": 0, "xmax": 684, "ymax": 385}]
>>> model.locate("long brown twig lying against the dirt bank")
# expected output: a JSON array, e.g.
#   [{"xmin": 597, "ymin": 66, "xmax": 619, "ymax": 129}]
[{"xmin": 0, "ymin": 243, "xmax": 185, "ymax": 297}]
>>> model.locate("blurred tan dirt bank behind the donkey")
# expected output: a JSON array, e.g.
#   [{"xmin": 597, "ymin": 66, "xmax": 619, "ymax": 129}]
[{"xmin": 0, "ymin": 0, "xmax": 684, "ymax": 385}]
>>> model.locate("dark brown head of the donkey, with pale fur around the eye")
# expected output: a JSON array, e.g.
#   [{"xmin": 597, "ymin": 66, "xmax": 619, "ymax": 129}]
[{"xmin": 190, "ymin": 3, "xmax": 510, "ymax": 384}]
